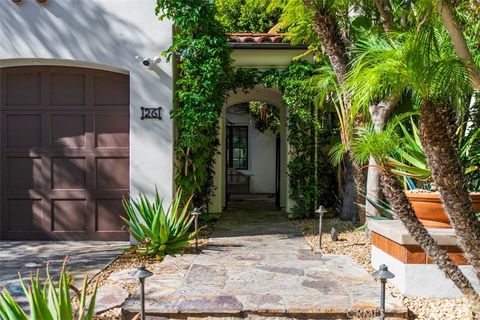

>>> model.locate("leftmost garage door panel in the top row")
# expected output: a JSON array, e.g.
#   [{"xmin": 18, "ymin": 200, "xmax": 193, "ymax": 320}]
[{"xmin": 5, "ymin": 72, "xmax": 42, "ymax": 106}]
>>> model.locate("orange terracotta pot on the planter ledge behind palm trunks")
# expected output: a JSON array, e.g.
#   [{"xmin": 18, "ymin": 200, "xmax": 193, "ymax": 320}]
[{"xmin": 405, "ymin": 191, "xmax": 480, "ymax": 228}]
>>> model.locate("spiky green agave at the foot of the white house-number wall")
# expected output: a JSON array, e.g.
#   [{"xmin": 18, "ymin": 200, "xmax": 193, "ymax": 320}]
[{"xmin": 121, "ymin": 191, "xmax": 195, "ymax": 257}]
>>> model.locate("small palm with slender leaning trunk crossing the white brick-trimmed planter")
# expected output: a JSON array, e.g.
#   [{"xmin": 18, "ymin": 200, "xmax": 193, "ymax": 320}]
[{"xmin": 350, "ymin": 122, "xmax": 480, "ymax": 315}]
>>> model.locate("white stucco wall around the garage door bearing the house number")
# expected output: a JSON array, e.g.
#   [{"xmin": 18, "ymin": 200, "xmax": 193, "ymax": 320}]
[{"xmin": 0, "ymin": 0, "xmax": 173, "ymax": 203}]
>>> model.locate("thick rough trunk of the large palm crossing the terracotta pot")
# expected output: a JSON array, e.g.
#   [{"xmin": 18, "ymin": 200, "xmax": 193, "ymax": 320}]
[{"xmin": 420, "ymin": 101, "xmax": 480, "ymax": 279}]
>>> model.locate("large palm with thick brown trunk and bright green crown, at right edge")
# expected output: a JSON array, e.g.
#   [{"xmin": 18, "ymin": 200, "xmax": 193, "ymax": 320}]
[{"xmin": 348, "ymin": 24, "xmax": 480, "ymax": 279}]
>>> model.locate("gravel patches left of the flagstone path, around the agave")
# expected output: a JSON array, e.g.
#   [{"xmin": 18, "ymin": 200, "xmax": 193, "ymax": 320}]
[{"xmin": 73, "ymin": 222, "xmax": 214, "ymax": 320}]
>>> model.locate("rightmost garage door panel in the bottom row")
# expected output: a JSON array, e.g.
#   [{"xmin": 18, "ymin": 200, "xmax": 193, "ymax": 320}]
[{"xmin": 95, "ymin": 198, "xmax": 126, "ymax": 232}]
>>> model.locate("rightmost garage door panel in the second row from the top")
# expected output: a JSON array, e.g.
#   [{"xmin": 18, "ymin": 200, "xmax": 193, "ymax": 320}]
[{"xmin": 95, "ymin": 113, "xmax": 129, "ymax": 148}]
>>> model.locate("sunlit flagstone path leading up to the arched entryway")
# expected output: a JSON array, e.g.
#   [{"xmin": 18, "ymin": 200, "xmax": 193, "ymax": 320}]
[{"xmin": 123, "ymin": 211, "xmax": 406, "ymax": 319}]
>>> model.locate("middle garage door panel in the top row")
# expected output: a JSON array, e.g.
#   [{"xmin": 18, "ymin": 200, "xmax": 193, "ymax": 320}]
[{"xmin": 50, "ymin": 73, "xmax": 85, "ymax": 106}]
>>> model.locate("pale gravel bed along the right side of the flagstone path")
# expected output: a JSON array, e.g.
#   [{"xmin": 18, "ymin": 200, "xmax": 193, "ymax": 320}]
[{"xmin": 293, "ymin": 218, "xmax": 473, "ymax": 320}]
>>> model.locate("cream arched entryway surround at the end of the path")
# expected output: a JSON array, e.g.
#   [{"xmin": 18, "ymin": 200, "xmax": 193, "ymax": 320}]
[{"xmin": 209, "ymin": 85, "xmax": 292, "ymax": 213}]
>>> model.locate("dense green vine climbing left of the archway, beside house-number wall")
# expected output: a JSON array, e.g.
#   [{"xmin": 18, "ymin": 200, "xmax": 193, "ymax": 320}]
[{"xmin": 156, "ymin": 0, "xmax": 233, "ymax": 205}]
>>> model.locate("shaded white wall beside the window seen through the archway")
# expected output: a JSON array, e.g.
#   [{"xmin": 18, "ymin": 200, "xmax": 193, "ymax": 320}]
[{"xmin": 227, "ymin": 107, "xmax": 276, "ymax": 193}]
